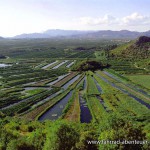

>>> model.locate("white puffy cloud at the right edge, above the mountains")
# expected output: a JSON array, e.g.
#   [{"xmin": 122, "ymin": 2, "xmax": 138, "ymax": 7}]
[{"xmin": 122, "ymin": 12, "xmax": 150, "ymax": 26}]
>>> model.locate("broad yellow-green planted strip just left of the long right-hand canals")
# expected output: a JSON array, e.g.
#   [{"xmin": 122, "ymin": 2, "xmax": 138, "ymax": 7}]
[{"xmin": 92, "ymin": 71, "xmax": 149, "ymax": 115}]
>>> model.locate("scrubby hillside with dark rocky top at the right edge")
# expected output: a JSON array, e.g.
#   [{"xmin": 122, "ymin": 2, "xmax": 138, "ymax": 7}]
[{"xmin": 111, "ymin": 36, "xmax": 150, "ymax": 59}]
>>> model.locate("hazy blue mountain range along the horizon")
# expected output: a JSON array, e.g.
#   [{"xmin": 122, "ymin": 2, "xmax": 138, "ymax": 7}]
[{"xmin": 13, "ymin": 29, "xmax": 150, "ymax": 39}]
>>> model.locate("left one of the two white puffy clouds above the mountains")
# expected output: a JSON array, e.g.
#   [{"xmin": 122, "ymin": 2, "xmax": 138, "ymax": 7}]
[{"xmin": 79, "ymin": 14, "xmax": 117, "ymax": 25}]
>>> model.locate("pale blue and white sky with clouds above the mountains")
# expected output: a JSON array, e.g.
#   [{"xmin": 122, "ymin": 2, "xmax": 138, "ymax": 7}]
[{"xmin": 0, "ymin": 0, "xmax": 150, "ymax": 37}]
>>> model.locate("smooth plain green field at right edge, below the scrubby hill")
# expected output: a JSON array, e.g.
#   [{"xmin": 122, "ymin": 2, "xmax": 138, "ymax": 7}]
[{"xmin": 126, "ymin": 75, "xmax": 150, "ymax": 89}]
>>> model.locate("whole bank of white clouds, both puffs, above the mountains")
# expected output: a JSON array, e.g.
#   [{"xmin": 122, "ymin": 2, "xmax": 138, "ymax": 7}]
[{"xmin": 79, "ymin": 12, "xmax": 150, "ymax": 27}]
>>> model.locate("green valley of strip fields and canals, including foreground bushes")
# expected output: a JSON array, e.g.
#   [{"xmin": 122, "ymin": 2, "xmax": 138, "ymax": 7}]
[{"xmin": 0, "ymin": 39, "xmax": 150, "ymax": 150}]
